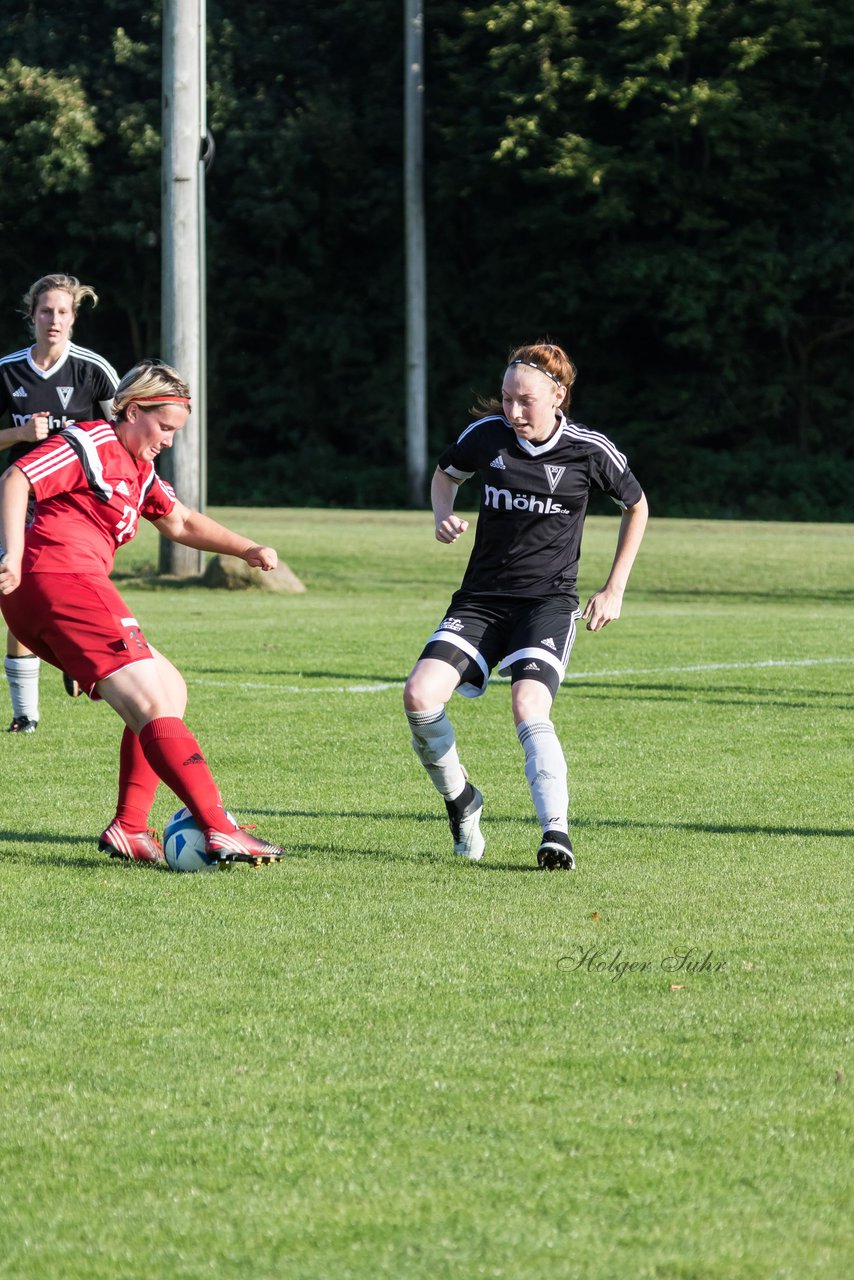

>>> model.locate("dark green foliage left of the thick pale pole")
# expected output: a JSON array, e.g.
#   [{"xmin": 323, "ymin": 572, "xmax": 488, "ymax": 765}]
[{"xmin": 0, "ymin": 0, "xmax": 160, "ymax": 355}]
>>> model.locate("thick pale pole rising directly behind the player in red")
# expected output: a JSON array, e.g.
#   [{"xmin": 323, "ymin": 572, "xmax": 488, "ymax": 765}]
[{"xmin": 160, "ymin": 0, "xmax": 206, "ymax": 577}]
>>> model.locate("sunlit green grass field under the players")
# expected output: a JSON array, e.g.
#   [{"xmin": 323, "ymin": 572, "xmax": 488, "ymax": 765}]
[{"xmin": 0, "ymin": 511, "xmax": 854, "ymax": 1280}]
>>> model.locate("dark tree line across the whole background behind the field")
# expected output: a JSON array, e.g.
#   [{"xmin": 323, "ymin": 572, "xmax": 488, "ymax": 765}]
[{"xmin": 0, "ymin": 0, "xmax": 854, "ymax": 520}]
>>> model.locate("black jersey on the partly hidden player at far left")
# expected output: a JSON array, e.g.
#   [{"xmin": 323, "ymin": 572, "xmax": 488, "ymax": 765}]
[{"xmin": 0, "ymin": 342, "xmax": 119, "ymax": 462}]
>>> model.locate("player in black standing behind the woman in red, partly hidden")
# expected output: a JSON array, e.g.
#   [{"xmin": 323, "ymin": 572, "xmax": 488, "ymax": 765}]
[{"xmin": 0, "ymin": 274, "xmax": 118, "ymax": 733}]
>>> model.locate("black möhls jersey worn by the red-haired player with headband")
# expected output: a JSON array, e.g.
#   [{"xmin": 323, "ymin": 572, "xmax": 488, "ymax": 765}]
[{"xmin": 439, "ymin": 415, "xmax": 643, "ymax": 596}]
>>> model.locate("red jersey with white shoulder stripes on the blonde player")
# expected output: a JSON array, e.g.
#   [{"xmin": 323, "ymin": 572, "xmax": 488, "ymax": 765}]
[{"xmin": 15, "ymin": 422, "xmax": 177, "ymax": 573}]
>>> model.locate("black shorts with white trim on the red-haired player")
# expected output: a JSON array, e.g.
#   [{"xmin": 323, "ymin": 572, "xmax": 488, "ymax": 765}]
[{"xmin": 421, "ymin": 591, "xmax": 581, "ymax": 698}]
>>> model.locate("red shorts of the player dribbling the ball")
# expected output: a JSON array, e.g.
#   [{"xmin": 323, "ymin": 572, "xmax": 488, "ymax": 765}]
[{"xmin": 0, "ymin": 573, "xmax": 154, "ymax": 696}]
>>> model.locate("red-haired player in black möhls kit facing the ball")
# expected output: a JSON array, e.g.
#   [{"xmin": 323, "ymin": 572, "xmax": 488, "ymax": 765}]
[{"xmin": 403, "ymin": 343, "xmax": 648, "ymax": 870}]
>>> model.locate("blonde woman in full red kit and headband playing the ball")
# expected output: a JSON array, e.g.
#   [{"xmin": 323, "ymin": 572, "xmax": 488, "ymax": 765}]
[{"xmin": 0, "ymin": 361, "xmax": 284, "ymax": 863}]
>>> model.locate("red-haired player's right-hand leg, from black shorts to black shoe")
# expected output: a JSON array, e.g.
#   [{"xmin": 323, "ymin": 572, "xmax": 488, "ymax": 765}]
[{"xmin": 501, "ymin": 602, "xmax": 577, "ymax": 870}]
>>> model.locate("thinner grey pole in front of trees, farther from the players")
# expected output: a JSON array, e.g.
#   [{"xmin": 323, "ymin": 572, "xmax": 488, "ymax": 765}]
[{"xmin": 403, "ymin": 0, "xmax": 426, "ymax": 507}]
